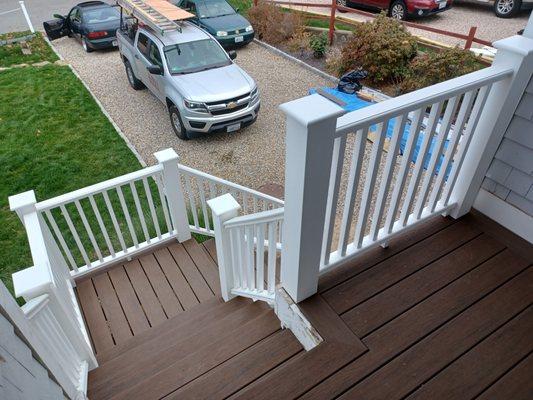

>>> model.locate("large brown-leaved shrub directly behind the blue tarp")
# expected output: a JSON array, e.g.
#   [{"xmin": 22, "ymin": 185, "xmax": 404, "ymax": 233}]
[{"xmin": 337, "ymin": 13, "xmax": 417, "ymax": 83}]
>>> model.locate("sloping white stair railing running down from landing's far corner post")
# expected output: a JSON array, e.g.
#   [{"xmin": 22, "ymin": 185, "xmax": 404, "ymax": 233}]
[{"xmin": 179, "ymin": 164, "xmax": 283, "ymax": 236}]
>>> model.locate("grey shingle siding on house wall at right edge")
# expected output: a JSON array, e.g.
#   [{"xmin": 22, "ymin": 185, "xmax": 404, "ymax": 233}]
[{"xmin": 483, "ymin": 74, "xmax": 533, "ymax": 216}]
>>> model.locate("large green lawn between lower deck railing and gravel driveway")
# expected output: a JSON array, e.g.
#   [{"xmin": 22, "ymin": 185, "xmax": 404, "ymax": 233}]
[{"xmin": 0, "ymin": 65, "xmax": 140, "ymax": 289}]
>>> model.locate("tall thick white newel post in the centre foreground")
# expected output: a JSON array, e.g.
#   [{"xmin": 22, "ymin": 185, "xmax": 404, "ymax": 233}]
[{"xmin": 280, "ymin": 94, "xmax": 345, "ymax": 302}]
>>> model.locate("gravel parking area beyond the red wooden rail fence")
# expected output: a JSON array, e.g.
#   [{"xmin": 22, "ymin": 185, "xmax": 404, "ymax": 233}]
[{"xmin": 295, "ymin": 0, "xmax": 531, "ymax": 46}]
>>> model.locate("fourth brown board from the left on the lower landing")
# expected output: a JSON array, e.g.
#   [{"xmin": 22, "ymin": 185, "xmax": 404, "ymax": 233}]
[{"xmin": 124, "ymin": 260, "xmax": 167, "ymax": 326}]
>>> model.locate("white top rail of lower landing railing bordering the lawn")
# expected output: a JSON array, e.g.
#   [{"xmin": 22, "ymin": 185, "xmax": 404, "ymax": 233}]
[{"xmin": 35, "ymin": 165, "xmax": 163, "ymax": 211}]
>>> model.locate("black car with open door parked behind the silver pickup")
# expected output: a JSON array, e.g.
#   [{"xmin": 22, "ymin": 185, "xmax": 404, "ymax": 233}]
[{"xmin": 43, "ymin": 1, "xmax": 120, "ymax": 53}]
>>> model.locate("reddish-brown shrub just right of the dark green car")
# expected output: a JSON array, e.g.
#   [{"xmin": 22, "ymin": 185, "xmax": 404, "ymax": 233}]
[{"xmin": 248, "ymin": 2, "xmax": 304, "ymax": 44}]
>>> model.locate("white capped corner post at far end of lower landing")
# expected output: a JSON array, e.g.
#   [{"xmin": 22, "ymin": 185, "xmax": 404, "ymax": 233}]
[{"xmin": 154, "ymin": 149, "xmax": 191, "ymax": 242}]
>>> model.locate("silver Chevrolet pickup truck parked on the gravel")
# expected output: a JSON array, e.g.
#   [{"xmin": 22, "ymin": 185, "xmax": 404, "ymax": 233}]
[{"xmin": 117, "ymin": 22, "xmax": 260, "ymax": 140}]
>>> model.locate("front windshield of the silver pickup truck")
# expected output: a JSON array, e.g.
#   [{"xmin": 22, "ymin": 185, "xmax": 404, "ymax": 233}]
[{"xmin": 164, "ymin": 39, "xmax": 231, "ymax": 74}]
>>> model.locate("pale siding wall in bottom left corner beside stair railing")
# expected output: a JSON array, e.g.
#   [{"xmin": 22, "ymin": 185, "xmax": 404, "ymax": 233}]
[{"xmin": 0, "ymin": 314, "xmax": 64, "ymax": 400}]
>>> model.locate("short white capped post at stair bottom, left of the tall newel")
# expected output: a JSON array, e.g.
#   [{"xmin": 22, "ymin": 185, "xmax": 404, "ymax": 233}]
[{"xmin": 207, "ymin": 193, "xmax": 241, "ymax": 301}]
